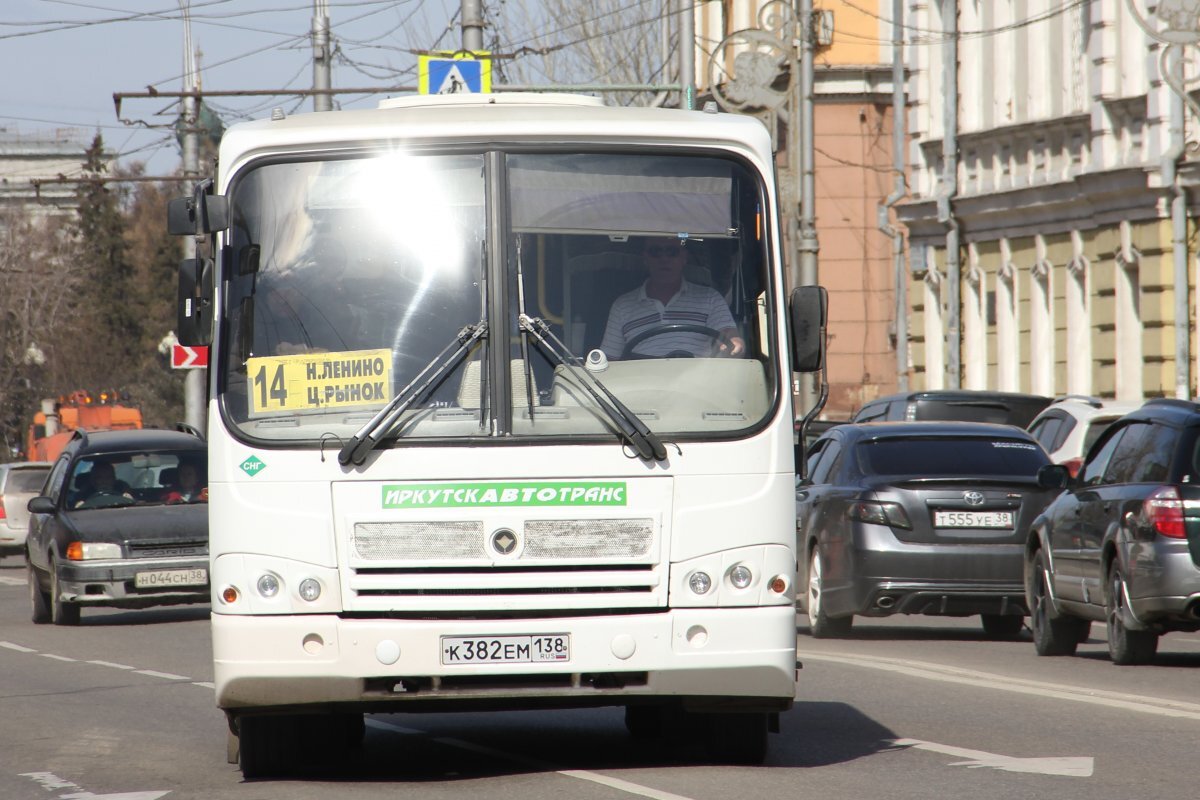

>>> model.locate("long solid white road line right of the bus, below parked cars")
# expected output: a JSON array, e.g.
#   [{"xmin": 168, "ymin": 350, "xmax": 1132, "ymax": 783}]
[{"xmin": 804, "ymin": 652, "xmax": 1200, "ymax": 720}]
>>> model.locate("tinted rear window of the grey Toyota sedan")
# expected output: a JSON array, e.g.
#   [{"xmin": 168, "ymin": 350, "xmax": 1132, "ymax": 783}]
[{"xmin": 857, "ymin": 437, "xmax": 1049, "ymax": 477}]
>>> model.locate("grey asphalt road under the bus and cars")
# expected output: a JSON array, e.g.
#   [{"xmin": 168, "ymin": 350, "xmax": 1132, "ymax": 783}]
[{"xmin": 0, "ymin": 558, "xmax": 1200, "ymax": 800}]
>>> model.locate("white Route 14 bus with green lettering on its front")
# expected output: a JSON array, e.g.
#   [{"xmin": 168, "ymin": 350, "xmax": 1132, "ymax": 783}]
[{"xmin": 168, "ymin": 94, "xmax": 824, "ymax": 776}]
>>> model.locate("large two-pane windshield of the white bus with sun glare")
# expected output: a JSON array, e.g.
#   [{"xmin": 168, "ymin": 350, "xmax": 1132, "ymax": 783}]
[{"xmin": 218, "ymin": 152, "xmax": 779, "ymax": 445}]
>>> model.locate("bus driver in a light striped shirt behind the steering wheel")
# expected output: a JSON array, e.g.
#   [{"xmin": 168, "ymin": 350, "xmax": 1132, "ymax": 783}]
[{"xmin": 600, "ymin": 236, "xmax": 746, "ymax": 359}]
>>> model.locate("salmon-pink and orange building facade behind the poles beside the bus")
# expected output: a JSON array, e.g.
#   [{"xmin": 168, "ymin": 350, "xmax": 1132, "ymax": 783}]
[{"xmin": 695, "ymin": 0, "xmax": 902, "ymax": 419}]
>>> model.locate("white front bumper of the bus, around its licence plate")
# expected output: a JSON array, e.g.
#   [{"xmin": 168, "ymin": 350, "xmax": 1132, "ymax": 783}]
[{"xmin": 212, "ymin": 604, "xmax": 797, "ymax": 714}]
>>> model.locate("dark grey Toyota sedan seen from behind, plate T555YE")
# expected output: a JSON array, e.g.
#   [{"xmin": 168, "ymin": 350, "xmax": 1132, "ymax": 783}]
[{"xmin": 796, "ymin": 422, "xmax": 1057, "ymax": 638}]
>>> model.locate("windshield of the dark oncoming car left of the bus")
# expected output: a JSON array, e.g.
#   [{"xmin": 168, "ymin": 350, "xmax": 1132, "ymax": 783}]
[{"xmin": 66, "ymin": 450, "xmax": 209, "ymax": 510}]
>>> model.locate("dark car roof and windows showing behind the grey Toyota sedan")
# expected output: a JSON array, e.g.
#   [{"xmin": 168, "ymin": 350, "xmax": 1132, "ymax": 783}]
[{"xmin": 853, "ymin": 389, "xmax": 1050, "ymax": 428}]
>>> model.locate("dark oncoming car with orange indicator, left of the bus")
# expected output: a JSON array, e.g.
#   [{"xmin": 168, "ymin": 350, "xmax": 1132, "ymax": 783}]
[{"xmin": 25, "ymin": 429, "xmax": 209, "ymax": 625}]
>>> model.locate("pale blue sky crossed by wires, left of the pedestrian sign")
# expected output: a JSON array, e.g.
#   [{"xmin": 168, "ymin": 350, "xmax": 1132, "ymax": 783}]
[{"xmin": 0, "ymin": 0, "xmax": 462, "ymax": 175}]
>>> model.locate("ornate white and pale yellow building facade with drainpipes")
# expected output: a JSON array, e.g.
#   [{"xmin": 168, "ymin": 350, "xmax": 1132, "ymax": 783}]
[{"xmin": 899, "ymin": 0, "xmax": 1200, "ymax": 401}]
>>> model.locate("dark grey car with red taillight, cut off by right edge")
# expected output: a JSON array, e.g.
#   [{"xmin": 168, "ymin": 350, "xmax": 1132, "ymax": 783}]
[{"xmin": 1025, "ymin": 399, "xmax": 1200, "ymax": 664}]
